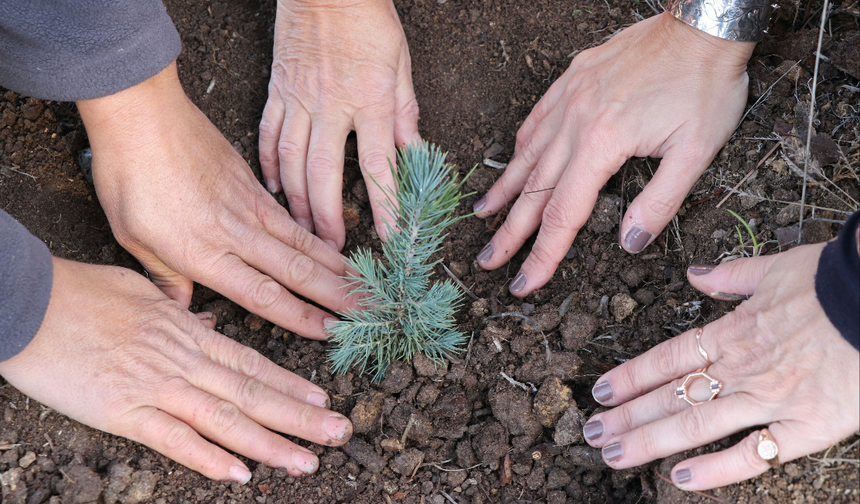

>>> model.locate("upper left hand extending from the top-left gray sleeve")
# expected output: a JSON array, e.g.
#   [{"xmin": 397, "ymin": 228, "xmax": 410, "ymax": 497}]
[{"xmin": 78, "ymin": 64, "xmax": 356, "ymax": 339}]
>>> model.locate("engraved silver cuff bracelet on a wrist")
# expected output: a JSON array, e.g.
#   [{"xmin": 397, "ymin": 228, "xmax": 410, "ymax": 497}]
[{"xmin": 666, "ymin": 0, "xmax": 773, "ymax": 42}]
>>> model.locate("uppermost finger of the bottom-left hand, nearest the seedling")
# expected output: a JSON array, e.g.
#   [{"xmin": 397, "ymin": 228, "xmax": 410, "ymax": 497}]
[{"xmin": 198, "ymin": 333, "xmax": 330, "ymax": 409}]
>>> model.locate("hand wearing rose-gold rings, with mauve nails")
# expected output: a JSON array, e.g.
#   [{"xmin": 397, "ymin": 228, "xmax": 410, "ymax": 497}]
[{"xmin": 583, "ymin": 244, "xmax": 860, "ymax": 490}]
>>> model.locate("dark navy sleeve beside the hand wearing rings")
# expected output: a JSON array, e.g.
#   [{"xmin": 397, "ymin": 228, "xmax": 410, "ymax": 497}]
[{"xmin": 815, "ymin": 212, "xmax": 860, "ymax": 350}]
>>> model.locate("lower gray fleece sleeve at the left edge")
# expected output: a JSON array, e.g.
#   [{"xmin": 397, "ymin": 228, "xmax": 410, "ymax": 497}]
[{"xmin": 0, "ymin": 210, "xmax": 54, "ymax": 361}]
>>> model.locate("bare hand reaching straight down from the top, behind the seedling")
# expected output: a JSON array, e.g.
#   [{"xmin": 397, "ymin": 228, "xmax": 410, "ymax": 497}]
[{"xmin": 260, "ymin": 0, "xmax": 420, "ymax": 250}]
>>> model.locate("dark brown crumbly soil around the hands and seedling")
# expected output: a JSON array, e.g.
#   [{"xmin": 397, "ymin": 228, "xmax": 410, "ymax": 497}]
[{"xmin": 0, "ymin": 0, "xmax": 860, "ymax": 504}]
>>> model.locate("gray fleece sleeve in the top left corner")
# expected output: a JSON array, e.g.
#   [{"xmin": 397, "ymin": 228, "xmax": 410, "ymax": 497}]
[{"xmin": 0, "ymin": 0, "xmax": 181, "ymax": 101}]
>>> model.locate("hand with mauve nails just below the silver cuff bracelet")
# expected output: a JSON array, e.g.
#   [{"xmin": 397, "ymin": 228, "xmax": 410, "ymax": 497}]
[{"xmin": 474, "ymin": 13, "xmax": 755, "ymax": 297}]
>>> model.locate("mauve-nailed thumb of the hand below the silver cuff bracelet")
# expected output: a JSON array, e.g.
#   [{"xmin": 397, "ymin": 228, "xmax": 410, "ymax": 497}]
[{"xmin": 620, "ymin": 141, "xmax": 716, "ymax": 254}]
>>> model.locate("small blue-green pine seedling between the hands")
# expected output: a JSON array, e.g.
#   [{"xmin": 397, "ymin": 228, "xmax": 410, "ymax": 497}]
[{"xmin": 328, "ymin": 141, "xmax": 471, "ymax": 380}]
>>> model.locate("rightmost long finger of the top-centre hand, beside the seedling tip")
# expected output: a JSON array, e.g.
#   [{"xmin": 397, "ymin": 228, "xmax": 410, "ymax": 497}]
[{"xmin": 355, "ymin": 110, "xmax": 396, "ymax": 240}]
